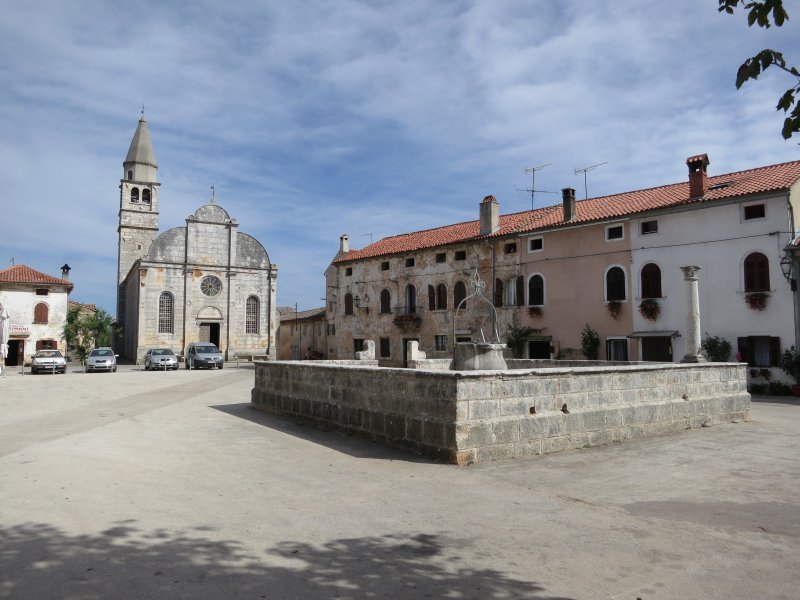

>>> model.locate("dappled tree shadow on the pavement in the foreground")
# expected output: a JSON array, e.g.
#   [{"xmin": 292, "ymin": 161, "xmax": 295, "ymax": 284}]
[{"xmin": 0, "ymin": 521, "xmax": 568, "ymax": 600}]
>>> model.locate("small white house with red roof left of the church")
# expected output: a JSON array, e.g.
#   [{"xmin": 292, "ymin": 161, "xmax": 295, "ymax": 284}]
[{"xmin": 0, "ymin": 265, "xmax": 72, "ymax": 367}]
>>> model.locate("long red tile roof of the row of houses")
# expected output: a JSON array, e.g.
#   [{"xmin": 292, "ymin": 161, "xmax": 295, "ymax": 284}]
[{"xmin": 334, "ymin": 155, "xmax": 800, "ymax": 263}]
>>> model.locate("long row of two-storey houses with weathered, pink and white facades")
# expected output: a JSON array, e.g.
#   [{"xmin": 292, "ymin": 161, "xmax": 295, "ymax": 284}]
[{"xmin": 326, "ymin": 154, "xmax": 800, "ymax": 381}]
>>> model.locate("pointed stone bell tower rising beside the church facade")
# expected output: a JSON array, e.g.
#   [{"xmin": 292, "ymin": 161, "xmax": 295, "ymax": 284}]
[{"xmin": 117, "ymin": 114, "xmax": 161, "ymax": 324}]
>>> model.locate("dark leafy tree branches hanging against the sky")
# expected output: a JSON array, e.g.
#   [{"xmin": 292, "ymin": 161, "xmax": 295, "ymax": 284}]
[{"xmin": 719, "ymin": 0, "xmax": 800, "ymax": 140}]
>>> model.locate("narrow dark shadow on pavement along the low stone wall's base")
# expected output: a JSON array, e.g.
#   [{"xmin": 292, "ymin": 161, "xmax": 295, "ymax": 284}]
[{"xmin": 210, "ymin": 402, "xmax": 435, "ymax": 464}]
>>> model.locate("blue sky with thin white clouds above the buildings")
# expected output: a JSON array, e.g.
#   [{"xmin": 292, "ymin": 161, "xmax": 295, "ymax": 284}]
[{"xmin": 0, "ymin": 0, "xmax": 800, "ymax": 315}]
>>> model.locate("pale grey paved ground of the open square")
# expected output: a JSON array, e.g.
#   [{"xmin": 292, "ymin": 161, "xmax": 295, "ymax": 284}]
[{"xmin": 0, "ymin": 365, "xmax": 800, "ymax": 600}]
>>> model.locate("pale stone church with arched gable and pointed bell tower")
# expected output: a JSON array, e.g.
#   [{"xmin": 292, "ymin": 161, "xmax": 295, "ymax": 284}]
[{"xmin": 116, "ymin": 116, "xmax": 279, "ymax": 364}]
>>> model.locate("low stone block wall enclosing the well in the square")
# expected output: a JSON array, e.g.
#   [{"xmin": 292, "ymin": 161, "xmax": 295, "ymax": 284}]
[{"xmin": 252, "ymin": 361, "xmax": 750, "ymax": 465}]
